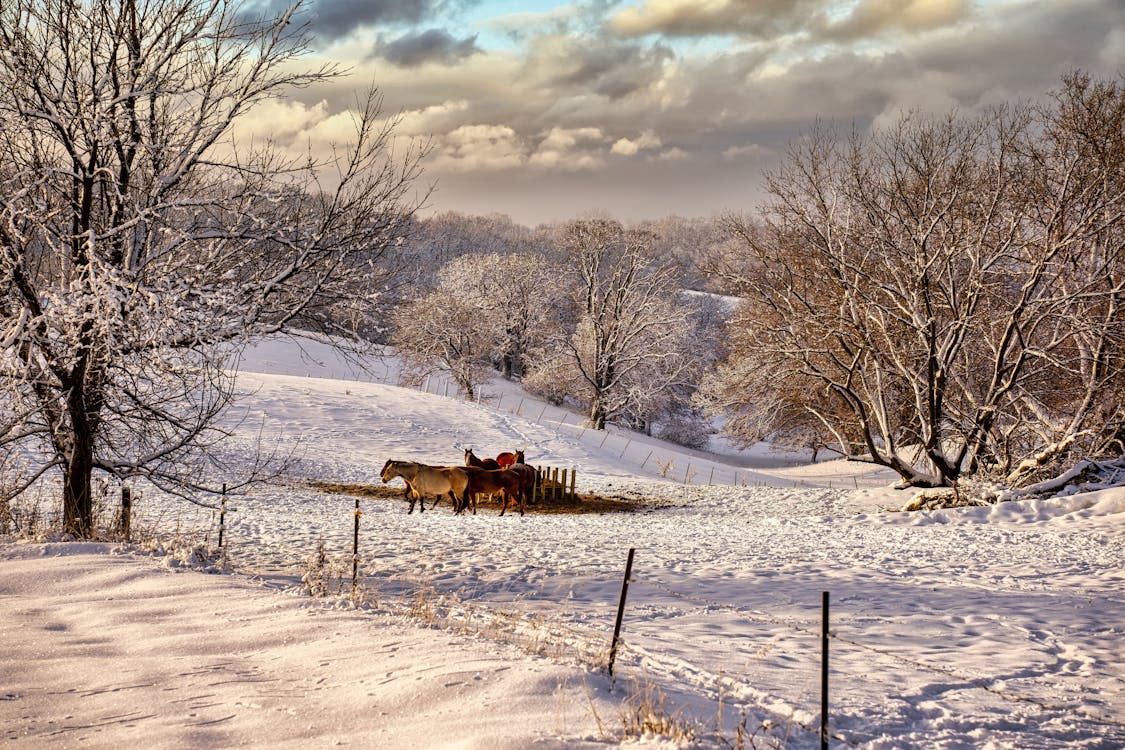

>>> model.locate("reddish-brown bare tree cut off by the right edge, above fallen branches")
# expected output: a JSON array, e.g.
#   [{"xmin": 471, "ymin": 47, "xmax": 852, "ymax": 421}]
[{"xmin": 998, "ymin": 72, "xmax": 1125, "ymax": 484}]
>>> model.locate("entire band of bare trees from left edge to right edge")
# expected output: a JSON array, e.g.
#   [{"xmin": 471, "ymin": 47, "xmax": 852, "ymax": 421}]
[{"xmin": 0, "ymin": 0, "xmax": 1125, "ymax": 536}]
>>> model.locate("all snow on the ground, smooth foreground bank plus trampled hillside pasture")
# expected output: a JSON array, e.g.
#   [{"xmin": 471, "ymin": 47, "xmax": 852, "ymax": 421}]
[{"xmin": 0, "ymin": 340, "xmax": 1125, "ymax": 750}]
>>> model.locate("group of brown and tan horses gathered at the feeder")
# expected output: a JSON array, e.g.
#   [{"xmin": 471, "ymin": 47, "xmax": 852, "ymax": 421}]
[{"xmin": 379, "ymin": 448, "xmax": 536, "ymax": 516}]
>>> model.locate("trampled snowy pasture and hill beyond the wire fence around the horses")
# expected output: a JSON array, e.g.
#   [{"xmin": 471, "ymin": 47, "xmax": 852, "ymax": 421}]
[{"xmin": 0, "ymin": 342, "xmax": 1125, "ymax": 749}]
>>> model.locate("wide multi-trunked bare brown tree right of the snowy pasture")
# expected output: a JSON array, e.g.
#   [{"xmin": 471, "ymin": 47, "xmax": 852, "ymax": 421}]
[{"xmin": 710, "ymin": 74, "xmax": 1123, "ymax": 485}]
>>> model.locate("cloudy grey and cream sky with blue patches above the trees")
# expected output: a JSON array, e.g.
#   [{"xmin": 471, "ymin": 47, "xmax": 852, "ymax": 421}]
[{"xmin": 251, "ymin": 0, "xmax": 1125, "ymax": 224}]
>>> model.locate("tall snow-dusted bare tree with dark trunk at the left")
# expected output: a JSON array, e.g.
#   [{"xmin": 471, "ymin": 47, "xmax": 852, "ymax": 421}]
[{"xmin": 0, "ymin": 0, "xmax": 421, "ymax": 536}]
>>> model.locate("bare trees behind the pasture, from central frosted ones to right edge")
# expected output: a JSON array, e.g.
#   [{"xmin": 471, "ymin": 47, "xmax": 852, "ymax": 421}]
[{"xmin": 390, "ymin": 72, "xmax": 1125, "ymax": 486}]
